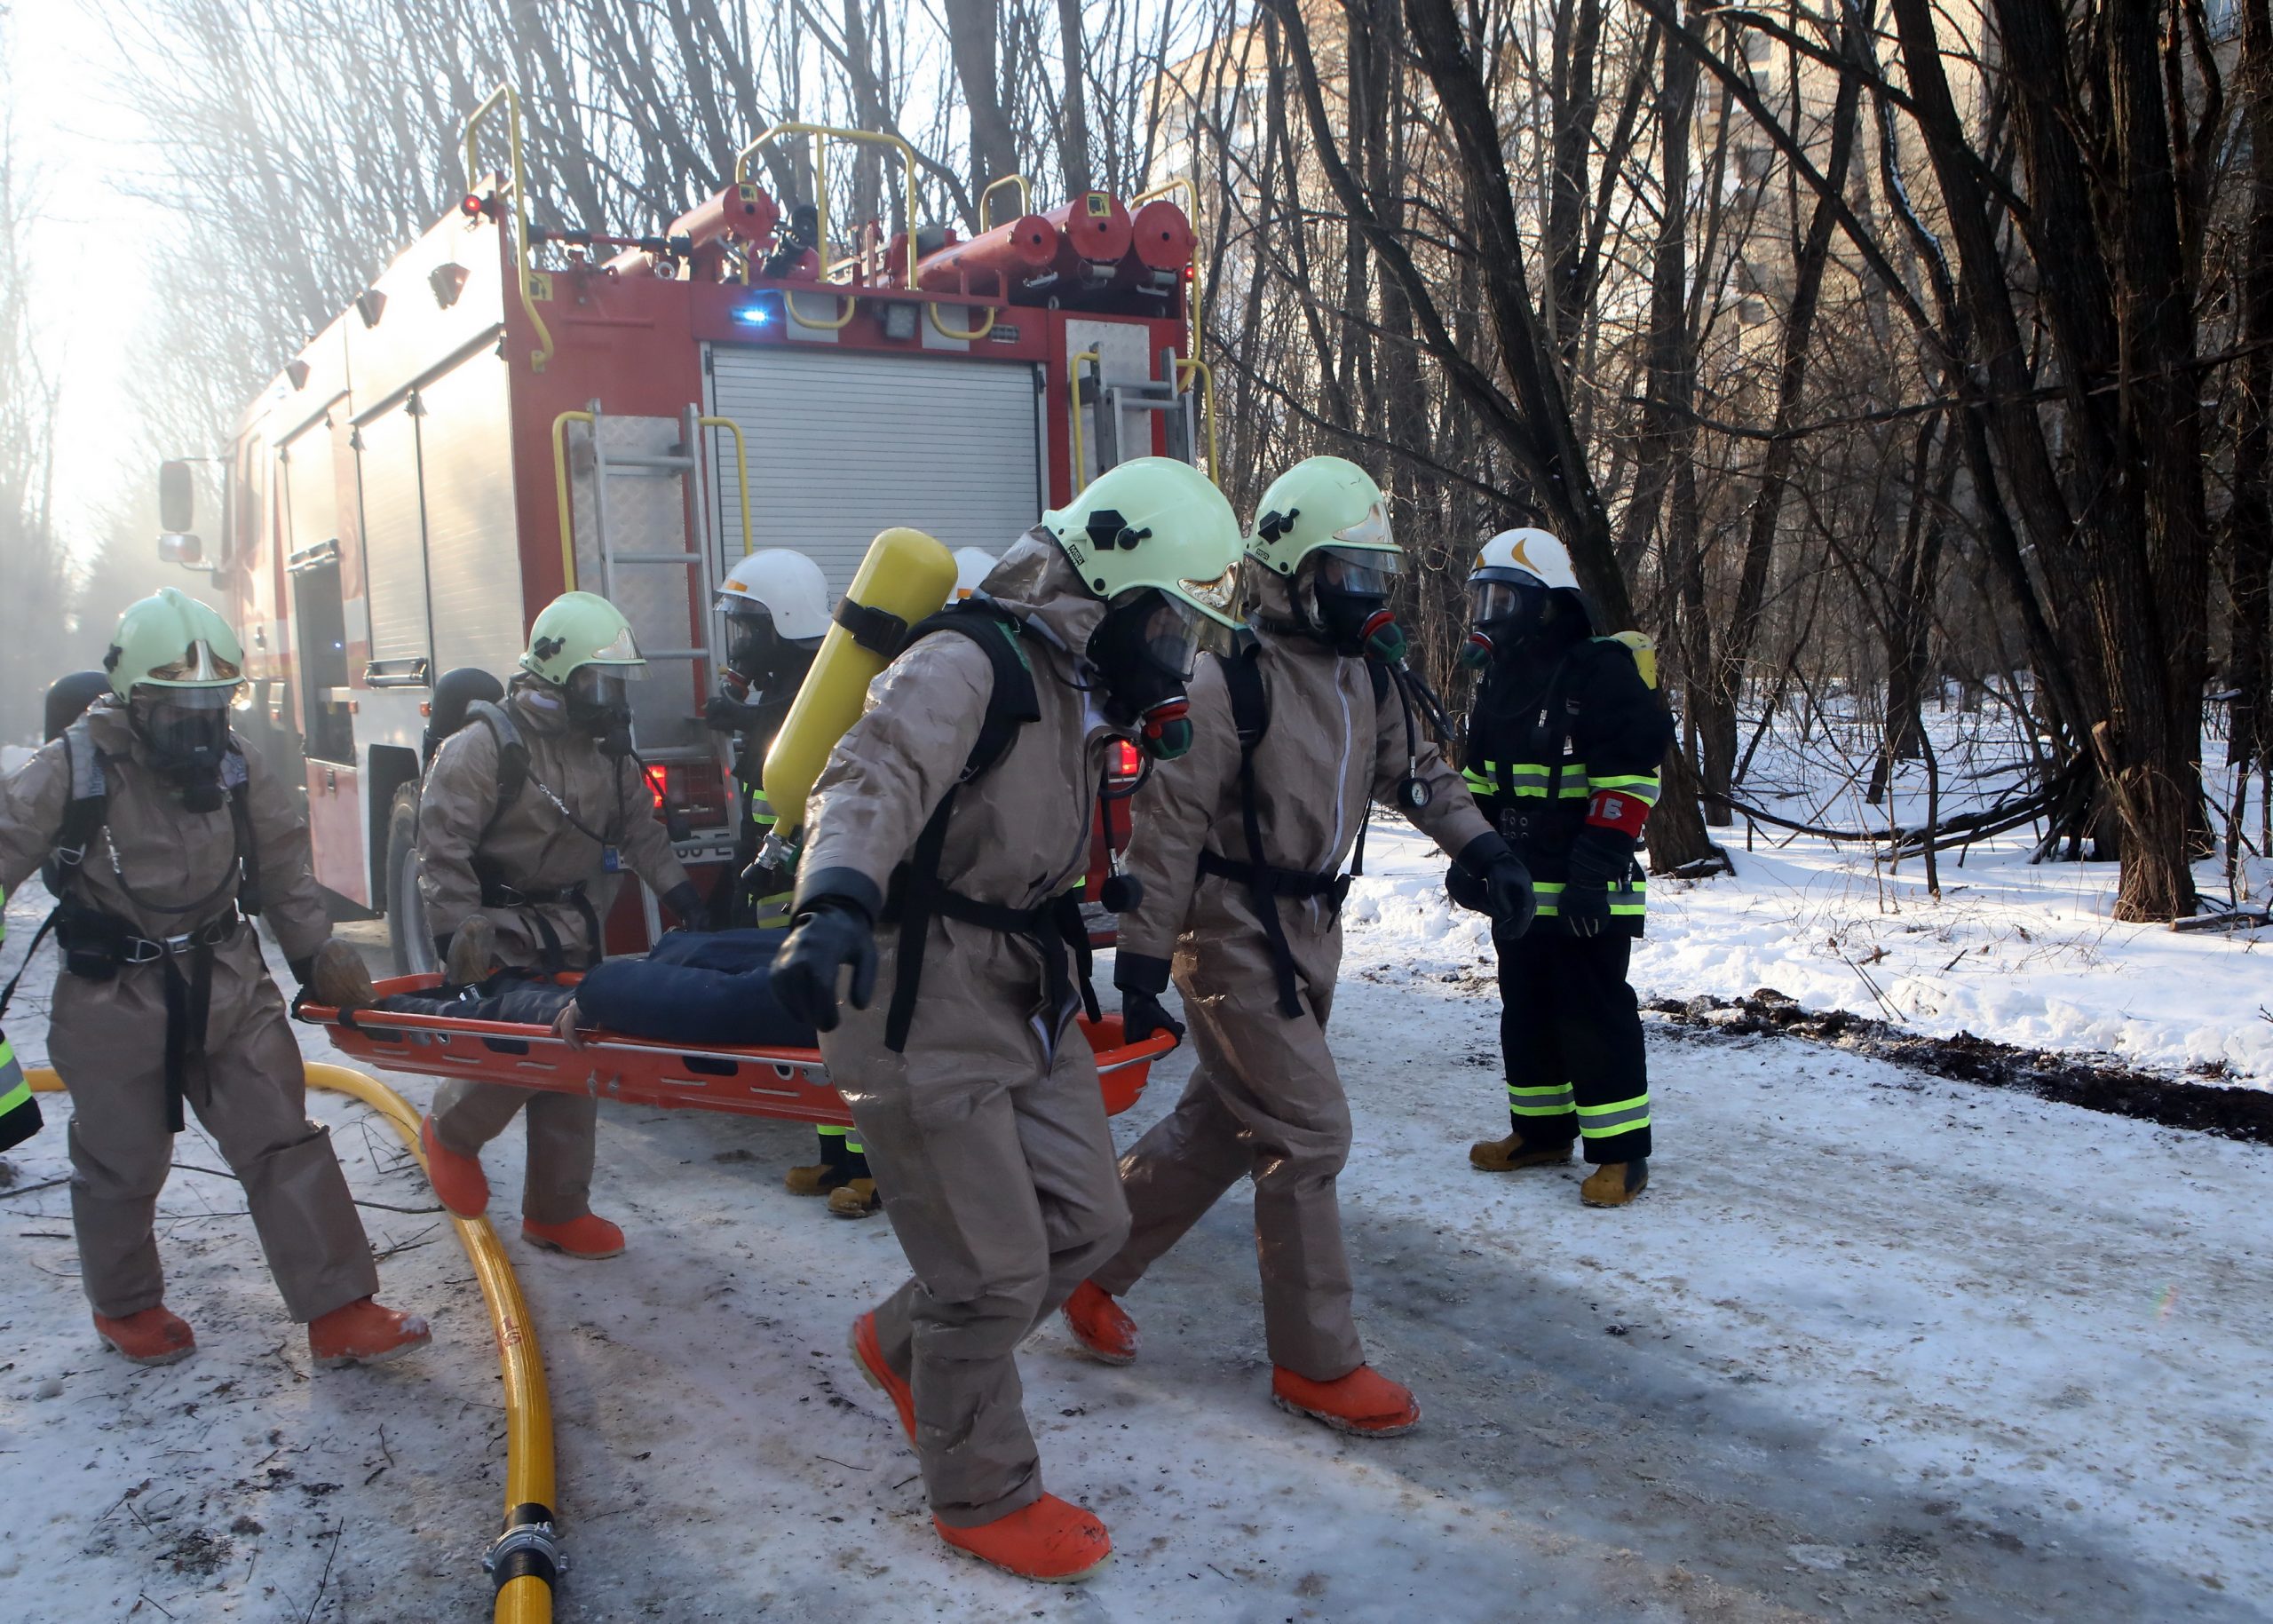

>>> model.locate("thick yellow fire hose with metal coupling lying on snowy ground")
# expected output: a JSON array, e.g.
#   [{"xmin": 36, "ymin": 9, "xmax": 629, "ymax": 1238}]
[{"xmin": 25, "ymin": 1062, "xmax": 568, "ymax": 1624}]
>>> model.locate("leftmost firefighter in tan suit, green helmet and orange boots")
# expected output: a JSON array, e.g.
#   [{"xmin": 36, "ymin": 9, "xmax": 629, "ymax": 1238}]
[{"xmin": 0, "ymin": 587, "xmax": 427, "ymax": 1365}]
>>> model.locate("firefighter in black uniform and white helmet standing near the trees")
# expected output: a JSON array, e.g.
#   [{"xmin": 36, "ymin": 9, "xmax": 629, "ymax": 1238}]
[{"xmin": 1445, "ymin": 530, "xmax": 1673, "ymax": 1206}]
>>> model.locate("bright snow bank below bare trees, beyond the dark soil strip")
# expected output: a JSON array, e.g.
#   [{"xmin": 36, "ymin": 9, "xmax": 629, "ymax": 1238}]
[{"xmin": 1348, "ymin": 709, "xmax": 2273, "ymax": 1087}]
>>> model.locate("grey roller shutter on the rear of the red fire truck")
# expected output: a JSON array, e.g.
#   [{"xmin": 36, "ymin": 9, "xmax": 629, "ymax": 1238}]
[{"xmin": 709, "ymin": 345, "xmax": 1046, "ymax": 594}]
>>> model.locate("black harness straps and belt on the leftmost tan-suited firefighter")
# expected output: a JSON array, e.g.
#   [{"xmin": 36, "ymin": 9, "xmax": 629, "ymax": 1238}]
[{"xmin": 0, "ymin": 717, "xmax": 261, "ymax": 1133}]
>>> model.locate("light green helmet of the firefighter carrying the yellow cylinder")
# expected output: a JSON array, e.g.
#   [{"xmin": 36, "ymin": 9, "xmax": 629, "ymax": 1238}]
[{"xmin": 1041, "ymin": 457, "xmax": 1241, "ymax": 625}]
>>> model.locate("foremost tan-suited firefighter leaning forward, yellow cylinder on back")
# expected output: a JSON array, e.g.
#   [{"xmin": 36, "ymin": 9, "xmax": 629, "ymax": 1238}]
[{"xmin": 772, "ymin": 457, "xmax": 1239, "ymax": 1580}]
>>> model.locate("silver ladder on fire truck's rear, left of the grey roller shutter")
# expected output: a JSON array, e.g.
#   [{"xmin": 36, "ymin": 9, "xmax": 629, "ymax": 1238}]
[{"xmin": 552, "ymin": 400, "xmax": 752, "ymax": 939}]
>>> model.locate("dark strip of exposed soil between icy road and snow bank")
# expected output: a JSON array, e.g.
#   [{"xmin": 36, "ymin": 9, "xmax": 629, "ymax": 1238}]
[{"xmin": 1645, "ymin": 987, "xmax": 2273, "ymax": 1144}]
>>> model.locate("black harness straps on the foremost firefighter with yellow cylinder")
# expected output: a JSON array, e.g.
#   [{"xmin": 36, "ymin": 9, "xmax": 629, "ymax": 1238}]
[{"xmin": 880, "ymin": 598, "xmax": 1105, "ymax": 1053}]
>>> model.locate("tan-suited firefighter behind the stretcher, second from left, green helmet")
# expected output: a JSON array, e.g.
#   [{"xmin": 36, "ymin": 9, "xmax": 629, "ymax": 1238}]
[{"xmin": 418, "ymin": 591, "xmax": 702, "ymax": 1258}]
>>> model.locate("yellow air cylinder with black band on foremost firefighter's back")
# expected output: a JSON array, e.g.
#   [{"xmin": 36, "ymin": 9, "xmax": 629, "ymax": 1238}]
[{"xmin": 766, "ymin": 526, "xmax": 954, "ymax": 839}]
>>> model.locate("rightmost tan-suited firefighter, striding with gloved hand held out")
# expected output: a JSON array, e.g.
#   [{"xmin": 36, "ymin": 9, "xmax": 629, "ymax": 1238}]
[{"xmin": 1066, "ymin": 457, "xmax": 1530, "ymax": 1435}]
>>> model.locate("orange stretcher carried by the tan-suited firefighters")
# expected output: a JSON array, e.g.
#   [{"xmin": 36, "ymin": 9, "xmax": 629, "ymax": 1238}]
[{"xmin": 300, "ymin": 976, "xmax": 1176, "ymax": 1129}]
